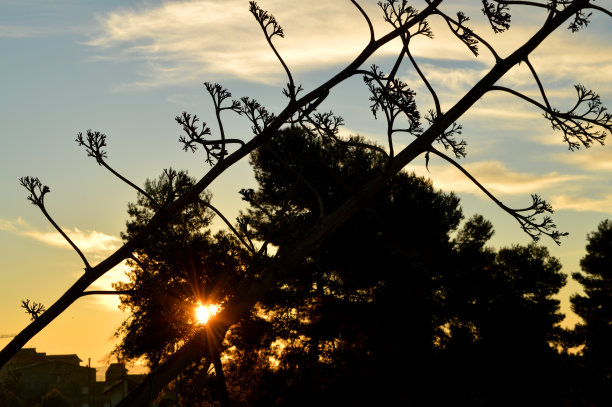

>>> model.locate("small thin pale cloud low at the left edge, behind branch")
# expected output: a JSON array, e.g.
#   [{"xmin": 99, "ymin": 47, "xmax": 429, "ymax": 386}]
[{"xmin": 0, "ymin": 217, "xmax": 121, "ymax": 255}]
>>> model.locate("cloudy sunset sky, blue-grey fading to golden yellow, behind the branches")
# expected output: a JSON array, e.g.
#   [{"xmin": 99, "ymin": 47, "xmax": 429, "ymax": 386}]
[{"xmin": 0, "ymin": 0, "xmax": 612, "ymax": 376}]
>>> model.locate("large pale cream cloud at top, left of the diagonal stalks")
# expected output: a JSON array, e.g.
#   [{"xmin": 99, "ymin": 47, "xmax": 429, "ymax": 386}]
[{"xmin": 87, "ymin": 0, "xmax": 378, "ymax": 87}]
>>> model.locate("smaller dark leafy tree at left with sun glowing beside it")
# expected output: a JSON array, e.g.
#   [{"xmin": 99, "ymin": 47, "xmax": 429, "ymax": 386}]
[{"xmin": 115, "ymin": 170, "xmax": 244, "ymax": 367}]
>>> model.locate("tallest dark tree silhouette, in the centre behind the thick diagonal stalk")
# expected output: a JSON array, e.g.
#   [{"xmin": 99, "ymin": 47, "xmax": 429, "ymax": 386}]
[{"xmin": 235, "ymin": 128, "xmax": 462, "ymax": 405}]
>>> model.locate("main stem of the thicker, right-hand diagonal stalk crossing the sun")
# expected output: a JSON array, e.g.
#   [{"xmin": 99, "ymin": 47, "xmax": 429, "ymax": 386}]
[{"xmin": 120, "ymin": 2, "xmax": 596, "ymax": 406}]
